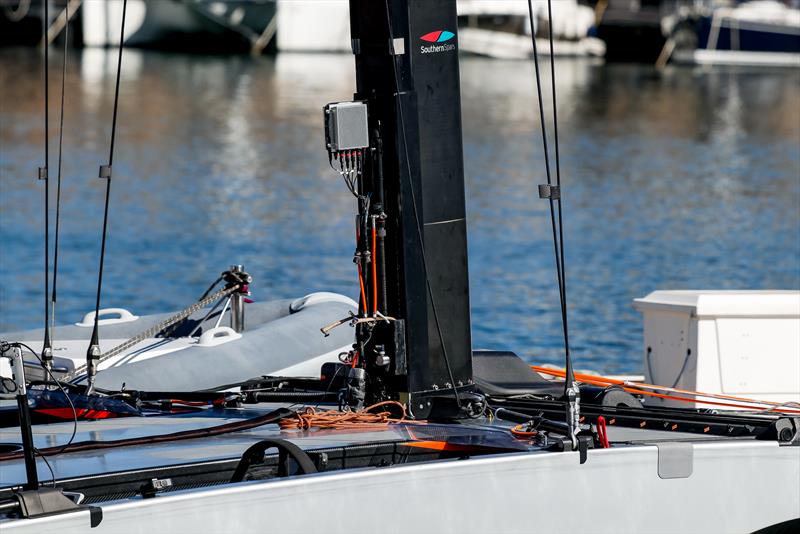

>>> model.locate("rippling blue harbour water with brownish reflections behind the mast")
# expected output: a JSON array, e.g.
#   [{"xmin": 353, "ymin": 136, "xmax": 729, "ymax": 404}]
[{"xmin": 0, "ymin": 50, "xmax": 800, "ymax": 372}]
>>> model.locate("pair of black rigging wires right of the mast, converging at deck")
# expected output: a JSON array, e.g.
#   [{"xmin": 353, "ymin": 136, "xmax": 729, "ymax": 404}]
[{"xmin": 528, "ymin": 0, "xmax": 575, "ymax": 390}]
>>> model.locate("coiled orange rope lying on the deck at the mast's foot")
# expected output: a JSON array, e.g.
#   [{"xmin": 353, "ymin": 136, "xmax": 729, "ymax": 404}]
[{"xmin": 278, "ymin": 401, "xmax": 410, "ymax": 430}]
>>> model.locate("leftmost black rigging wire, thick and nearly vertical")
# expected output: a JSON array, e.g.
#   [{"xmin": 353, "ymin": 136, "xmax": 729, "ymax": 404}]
[{"xmin": 39, "ymin": 0, "xmax": 53, "ymax": 364}]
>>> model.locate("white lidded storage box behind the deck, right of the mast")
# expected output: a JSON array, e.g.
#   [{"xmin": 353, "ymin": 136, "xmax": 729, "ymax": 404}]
[{"xmin": 634, "ymin": 291, "xmax": 800, "ymax": 407}]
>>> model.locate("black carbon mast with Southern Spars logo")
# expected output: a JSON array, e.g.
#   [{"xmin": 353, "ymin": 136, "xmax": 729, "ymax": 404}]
[{"xmin": 340, "ymin": 0, "xmax": 480, "ymax": 418}]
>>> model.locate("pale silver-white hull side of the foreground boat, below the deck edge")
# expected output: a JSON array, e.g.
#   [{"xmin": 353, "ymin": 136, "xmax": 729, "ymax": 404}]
[{"xmin": 3, "ymin": 441, "xmax": 800, "ymax": 534}]
